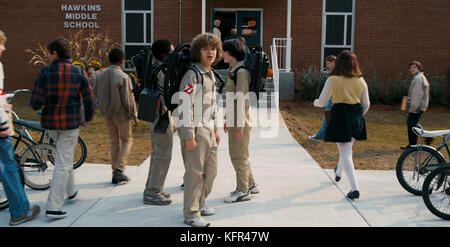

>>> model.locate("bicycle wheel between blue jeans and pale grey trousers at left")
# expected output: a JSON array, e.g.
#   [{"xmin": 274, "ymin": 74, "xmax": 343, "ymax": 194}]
[{"xmin": 20, "ymin": 144, "xmax": 56, "ymax": 190}]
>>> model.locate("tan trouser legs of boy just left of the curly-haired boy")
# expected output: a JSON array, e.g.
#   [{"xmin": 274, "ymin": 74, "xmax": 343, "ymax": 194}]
[{"xmin": 144, "ymin": 122, "xmax": 173, "ymax": 196}]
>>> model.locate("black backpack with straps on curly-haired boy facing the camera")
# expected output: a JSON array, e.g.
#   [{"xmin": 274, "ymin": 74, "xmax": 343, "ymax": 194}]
[{"xmin": 160, "ymin": 43, "xmax": 225, "ymax": 111}]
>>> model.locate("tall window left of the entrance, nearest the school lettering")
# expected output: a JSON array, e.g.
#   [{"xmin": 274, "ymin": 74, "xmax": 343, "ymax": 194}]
[{"xmin": 122, "ymin": 0, "xmax": 153, "ymax": 69}]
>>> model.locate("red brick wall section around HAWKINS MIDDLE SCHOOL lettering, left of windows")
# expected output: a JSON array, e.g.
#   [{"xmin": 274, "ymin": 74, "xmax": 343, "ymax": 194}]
[{"xmin": 0, "ymin": 0, "xmax": 121, "ymax": 91}]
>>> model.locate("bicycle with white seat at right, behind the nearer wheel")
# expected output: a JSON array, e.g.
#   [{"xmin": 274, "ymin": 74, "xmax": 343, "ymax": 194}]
[{"xmin": 396, "ymin": 124, "xmax": 450, "ymax": 196}]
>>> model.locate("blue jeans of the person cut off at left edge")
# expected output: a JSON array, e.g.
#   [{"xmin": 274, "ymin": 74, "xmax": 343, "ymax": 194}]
[{"xmin": 0, "ymin": 137, "xmax": 30, "ymax": 217}]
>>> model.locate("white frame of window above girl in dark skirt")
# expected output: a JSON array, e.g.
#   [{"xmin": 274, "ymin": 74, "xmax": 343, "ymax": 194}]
[{"xmin": 320, "ymin": 0, "xmax": 356, "ymax": 72}]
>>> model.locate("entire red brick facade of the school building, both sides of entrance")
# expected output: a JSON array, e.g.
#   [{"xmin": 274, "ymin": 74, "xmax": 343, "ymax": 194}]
[{"xmin": 0, "ymin": 0, "xmax": 450, "ymax": 90}]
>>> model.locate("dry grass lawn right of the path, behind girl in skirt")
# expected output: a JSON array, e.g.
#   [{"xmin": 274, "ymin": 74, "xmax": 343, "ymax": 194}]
[{"xmin": 280, "ymin": 101, "xmax": 450, "ymax": 170}]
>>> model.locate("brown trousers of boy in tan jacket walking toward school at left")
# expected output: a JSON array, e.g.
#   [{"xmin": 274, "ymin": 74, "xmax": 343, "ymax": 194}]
[{"xmin": 105, "ymin": 118, "xmax": 133, "ymax": 171}]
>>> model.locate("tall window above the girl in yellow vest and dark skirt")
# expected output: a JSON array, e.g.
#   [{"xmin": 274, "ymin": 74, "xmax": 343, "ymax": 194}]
[{"xmin": 321, "ymin": 0, "xmax": 355, "ymax": 70}]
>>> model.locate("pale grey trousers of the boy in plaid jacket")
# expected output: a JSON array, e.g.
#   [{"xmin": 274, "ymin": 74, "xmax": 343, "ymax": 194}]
[{"xmin": 47, "ymin": 128, "xmax": 80, "ymax": 211}]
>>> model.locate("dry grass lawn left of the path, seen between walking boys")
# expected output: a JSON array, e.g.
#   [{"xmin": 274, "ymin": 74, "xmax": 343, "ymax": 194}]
[{"xmin": 11, "ymin": 92, "xmax": 151, "ymax": 165}]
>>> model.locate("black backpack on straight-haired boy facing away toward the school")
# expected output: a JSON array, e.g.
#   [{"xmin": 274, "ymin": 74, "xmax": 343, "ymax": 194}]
[{"xmin": 231, "ymin": 46, "xmax": 269, "ymax": 99}]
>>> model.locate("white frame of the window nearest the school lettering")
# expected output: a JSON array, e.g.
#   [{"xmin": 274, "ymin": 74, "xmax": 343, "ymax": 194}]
[{"xmin": 121, "ymin": 0, "xmax": 154, "ymax": 71}]
